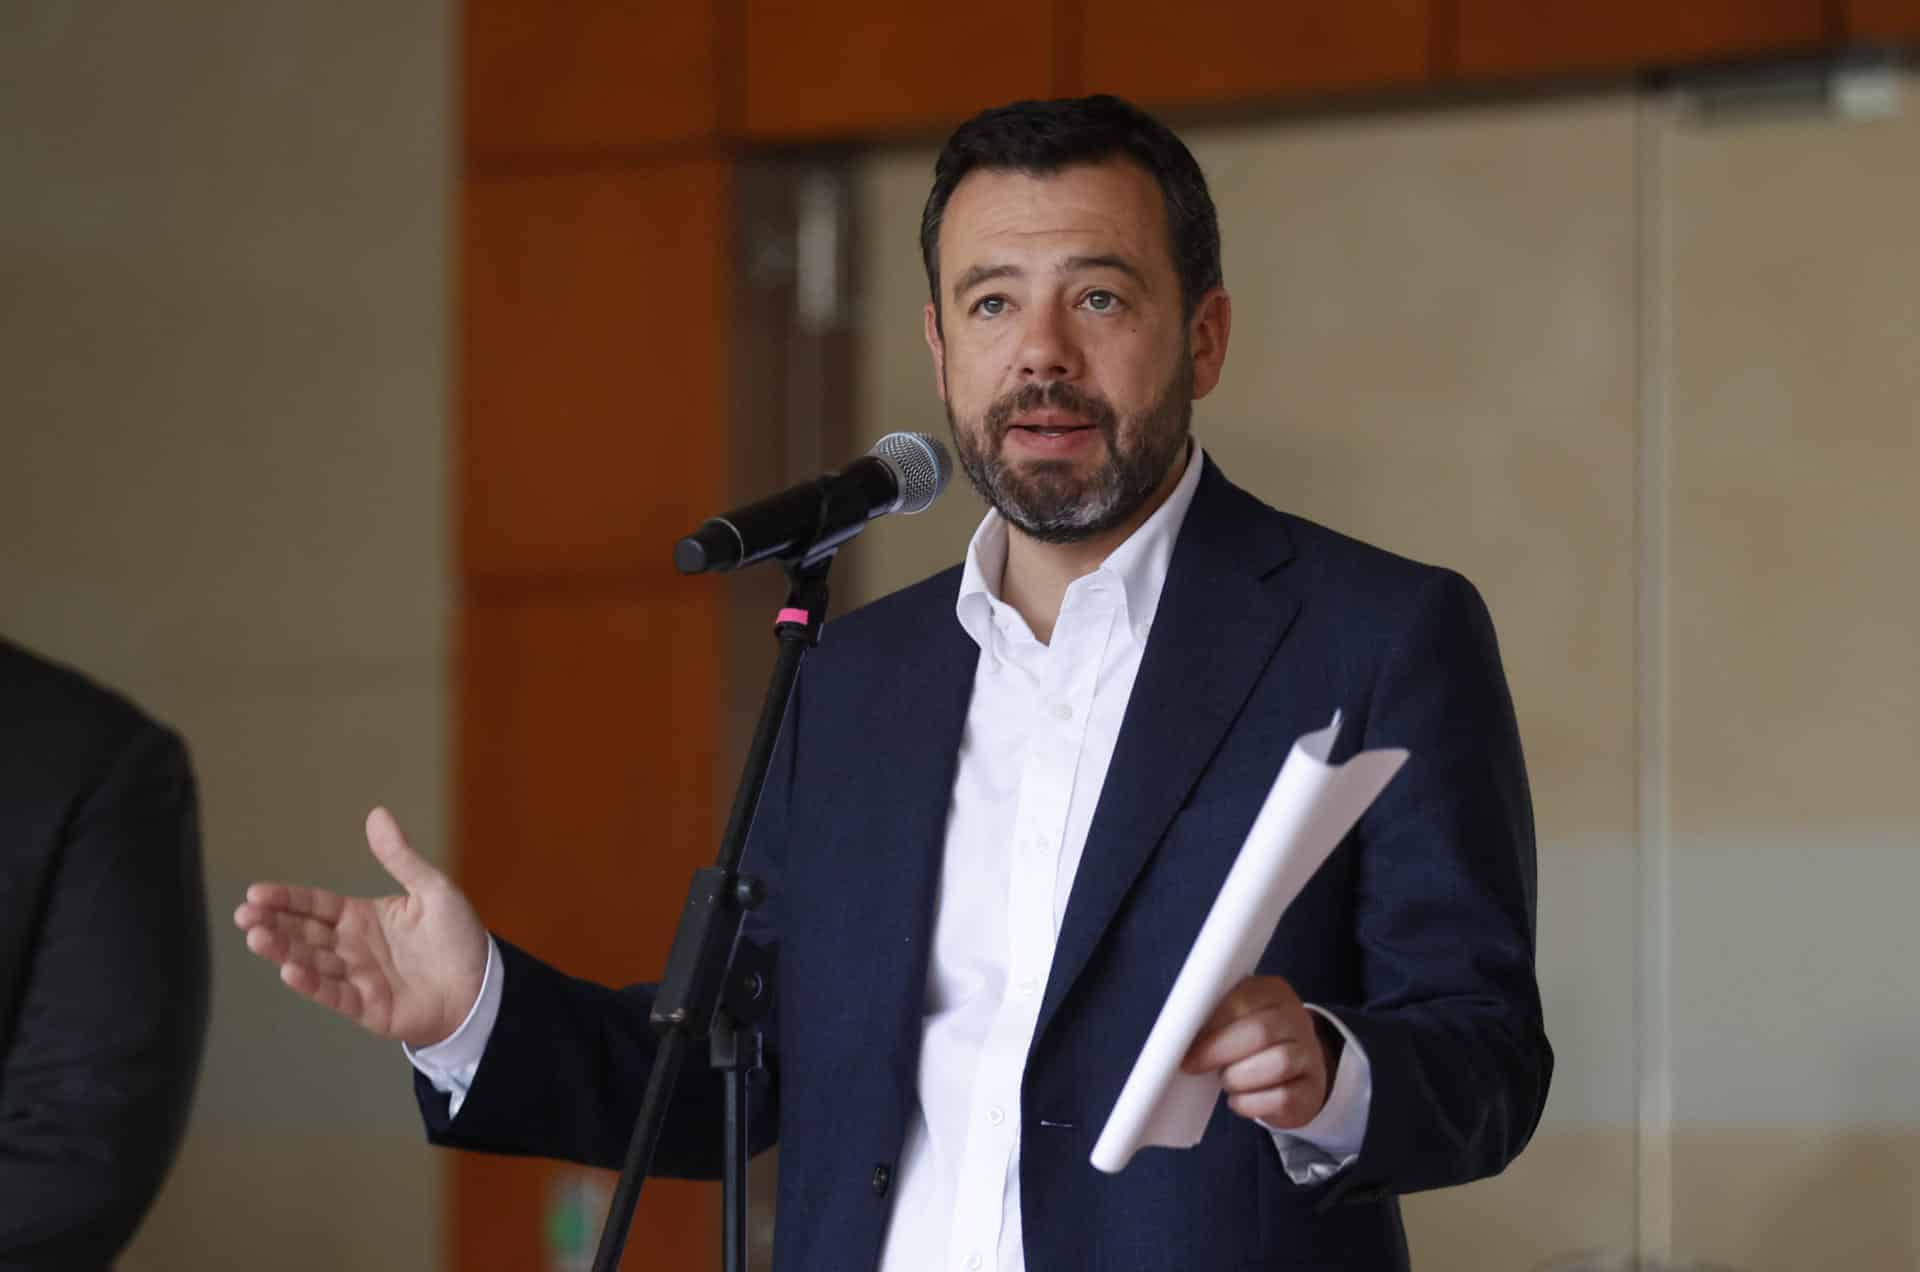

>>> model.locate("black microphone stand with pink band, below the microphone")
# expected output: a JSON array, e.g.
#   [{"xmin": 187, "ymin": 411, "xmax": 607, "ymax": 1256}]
[{"xmin": 593, "ymin": 548, "xmax": 833, "ymax": 1272}]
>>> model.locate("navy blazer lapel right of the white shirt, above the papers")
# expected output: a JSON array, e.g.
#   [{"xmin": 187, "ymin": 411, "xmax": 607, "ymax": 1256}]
[{"xmin": 1033, "ymin": 459, "xmax": 1298, "ymax": 1041}]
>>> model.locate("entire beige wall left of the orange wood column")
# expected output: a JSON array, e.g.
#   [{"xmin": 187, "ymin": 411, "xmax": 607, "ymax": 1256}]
[{"xmin": 0, "ymin": 0, "xmax": 451, "ymax": 1272}]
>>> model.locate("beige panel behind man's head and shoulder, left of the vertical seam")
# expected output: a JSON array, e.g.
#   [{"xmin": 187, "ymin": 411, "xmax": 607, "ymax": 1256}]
[{"xmin": 843, "ymin": 98, "xmax": 1636, "ymax": 1272}]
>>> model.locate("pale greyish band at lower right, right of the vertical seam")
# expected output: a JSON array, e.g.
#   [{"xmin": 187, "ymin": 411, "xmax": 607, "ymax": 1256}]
[{"xmin": 1668, "ymin": 837, "xmax": 1920, "ymax": 1137}]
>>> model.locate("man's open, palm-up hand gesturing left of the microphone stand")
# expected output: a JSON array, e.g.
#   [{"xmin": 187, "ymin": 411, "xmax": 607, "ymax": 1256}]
[{"xmin": 234, "ymin": 809, "xmax": 488, "ymax": 1047}]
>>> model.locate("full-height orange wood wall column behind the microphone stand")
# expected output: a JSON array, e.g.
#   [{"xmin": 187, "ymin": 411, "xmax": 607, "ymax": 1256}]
[{"xmin": 445, "ymin": 0, "xmax": 733, "ymax": 1268}]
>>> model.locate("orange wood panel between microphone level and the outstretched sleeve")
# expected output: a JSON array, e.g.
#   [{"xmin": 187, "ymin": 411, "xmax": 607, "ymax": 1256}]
[{"xmin": 459, "ymin": 591, "xmax": 724, "ymax": 984}]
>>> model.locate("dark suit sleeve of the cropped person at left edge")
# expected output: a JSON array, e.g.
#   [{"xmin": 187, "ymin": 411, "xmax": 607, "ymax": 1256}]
[{"xmin": 0, "ymin": 724, "xmax": 207, "ymax": 1268}]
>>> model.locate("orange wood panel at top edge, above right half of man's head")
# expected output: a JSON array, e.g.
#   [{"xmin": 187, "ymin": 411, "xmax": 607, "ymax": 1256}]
[{"xmin": 1073, "ymin": 0, "xmax": 1432, "ymax": 106}]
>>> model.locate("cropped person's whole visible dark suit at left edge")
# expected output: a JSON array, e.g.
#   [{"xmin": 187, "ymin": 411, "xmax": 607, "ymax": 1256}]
[{"xmin": 0, "ymin": 640, "xmax": 207, "ymax": 1268}]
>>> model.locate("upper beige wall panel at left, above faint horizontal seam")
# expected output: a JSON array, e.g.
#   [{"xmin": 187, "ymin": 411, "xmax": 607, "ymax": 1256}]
[{"xmin": 0, "ymin": 29, "xmax": 447, "ymax": 686}]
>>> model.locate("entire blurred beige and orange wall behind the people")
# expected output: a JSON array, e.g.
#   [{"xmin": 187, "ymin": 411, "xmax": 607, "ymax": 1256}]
[{"xmin": 0, "ymin": 0, "xmax": 1920, "ymax": 1272}]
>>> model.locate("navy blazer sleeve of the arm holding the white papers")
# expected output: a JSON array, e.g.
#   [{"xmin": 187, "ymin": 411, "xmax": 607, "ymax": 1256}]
[{"xmin": 1327, "ymin": 571, "xmax": 1553, "ymax": 1201}]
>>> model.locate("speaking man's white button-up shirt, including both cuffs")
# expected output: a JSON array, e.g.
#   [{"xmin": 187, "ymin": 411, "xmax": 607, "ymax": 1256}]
[{"xmin": 407, "ymin": 446, "xmax": 1373, "ymax": 1272}]
